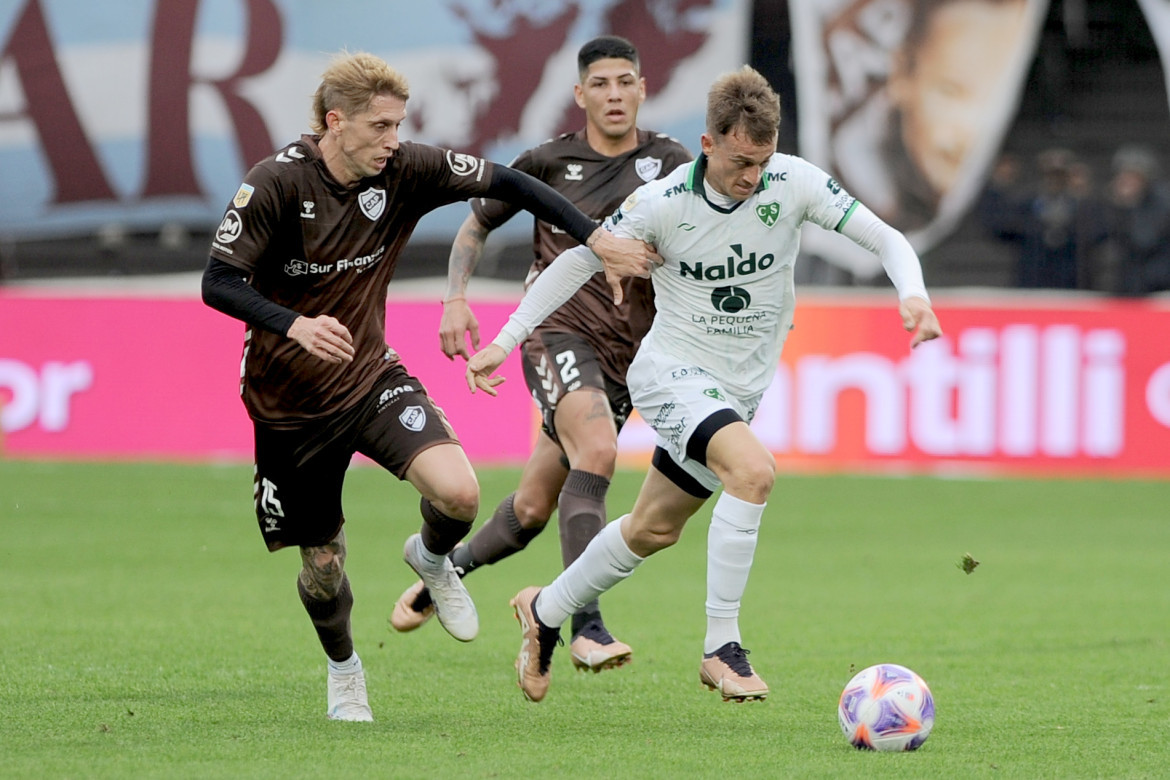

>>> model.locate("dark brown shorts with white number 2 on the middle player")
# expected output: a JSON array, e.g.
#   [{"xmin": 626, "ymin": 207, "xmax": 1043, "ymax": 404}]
[{"xmin": 522, "ymin": 330, "xmax": 634, "ymax": 444}]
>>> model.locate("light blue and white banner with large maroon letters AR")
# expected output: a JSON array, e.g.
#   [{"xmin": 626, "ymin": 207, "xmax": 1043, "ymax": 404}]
[{"xmin": 0, "ymin": 0, "xmax": 751, "ymax": 241}]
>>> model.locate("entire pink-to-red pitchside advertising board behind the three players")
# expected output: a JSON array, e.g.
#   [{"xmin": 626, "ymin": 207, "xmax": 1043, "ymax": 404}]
[{"xmin": 0, "ymin": 290, "xmax": 1170, "ymax": 478}]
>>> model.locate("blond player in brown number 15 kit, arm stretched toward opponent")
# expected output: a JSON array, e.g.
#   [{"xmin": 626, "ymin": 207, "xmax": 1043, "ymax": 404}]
[{"xmin": 204, "ymin": 47, "xmax": 658, "ymax": 720}]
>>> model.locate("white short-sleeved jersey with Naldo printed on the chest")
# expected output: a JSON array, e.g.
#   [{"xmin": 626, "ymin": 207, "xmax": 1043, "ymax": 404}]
[{"xmin": 610, "ymin": 153, "xmax": 856, "ymax": 398}]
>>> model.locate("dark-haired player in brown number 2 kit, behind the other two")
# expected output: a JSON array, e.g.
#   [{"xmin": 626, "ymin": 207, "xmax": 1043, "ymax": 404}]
[{"xmin": 391, "ymin": 36, "xmax": 691, "ymax": 671}]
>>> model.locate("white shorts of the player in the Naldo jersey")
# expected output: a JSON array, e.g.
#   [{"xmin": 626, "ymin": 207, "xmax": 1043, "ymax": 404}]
[{"xmin": 626, "ymin": 348, "xmax": 762, "ymax": 492}]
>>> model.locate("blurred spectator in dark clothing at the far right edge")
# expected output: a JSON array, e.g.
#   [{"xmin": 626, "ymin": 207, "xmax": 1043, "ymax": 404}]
[{"xmin": 1106, "ymin": 145, "xmax": 1170, "ymax": 295}]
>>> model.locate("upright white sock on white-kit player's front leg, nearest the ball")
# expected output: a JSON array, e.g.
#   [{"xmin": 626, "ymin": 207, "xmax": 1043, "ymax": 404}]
[{"xmin": 703, "ymin": 492, "xmax": 768, "ymax": 653}]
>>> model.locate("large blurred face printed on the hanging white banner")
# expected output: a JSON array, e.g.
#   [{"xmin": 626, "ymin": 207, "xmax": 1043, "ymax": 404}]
[{"xmin": 889, "ymin": 0, "xmax": 1024, "ymax": 195}]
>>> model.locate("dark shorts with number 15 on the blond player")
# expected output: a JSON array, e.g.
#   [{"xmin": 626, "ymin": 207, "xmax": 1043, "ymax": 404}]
[{"xmin": 253, "ymin": 364, "xmax": 459, "ymax": 550}]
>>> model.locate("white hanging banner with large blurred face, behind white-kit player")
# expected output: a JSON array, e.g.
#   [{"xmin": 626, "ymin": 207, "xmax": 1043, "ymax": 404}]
[{"xmin": 790, "ymin": 0, "xmax": 1048, "ymax": 276}]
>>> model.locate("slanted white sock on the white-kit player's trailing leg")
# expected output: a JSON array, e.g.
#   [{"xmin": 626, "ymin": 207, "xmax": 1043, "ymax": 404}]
[{"xmin": 534, "ymin": 515, "xmax": 646, "ymax": 628}]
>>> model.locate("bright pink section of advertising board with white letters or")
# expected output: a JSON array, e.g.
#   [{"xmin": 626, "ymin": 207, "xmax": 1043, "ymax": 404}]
[{"xmin": 0, "ymin": 291, "xmax": 534, "ymax": 461}]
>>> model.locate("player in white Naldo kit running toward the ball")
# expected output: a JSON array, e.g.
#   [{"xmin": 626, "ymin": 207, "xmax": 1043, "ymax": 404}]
[{"xmin": 467, "ymin": 67, "xmax": 942, "ymax": 702}]
